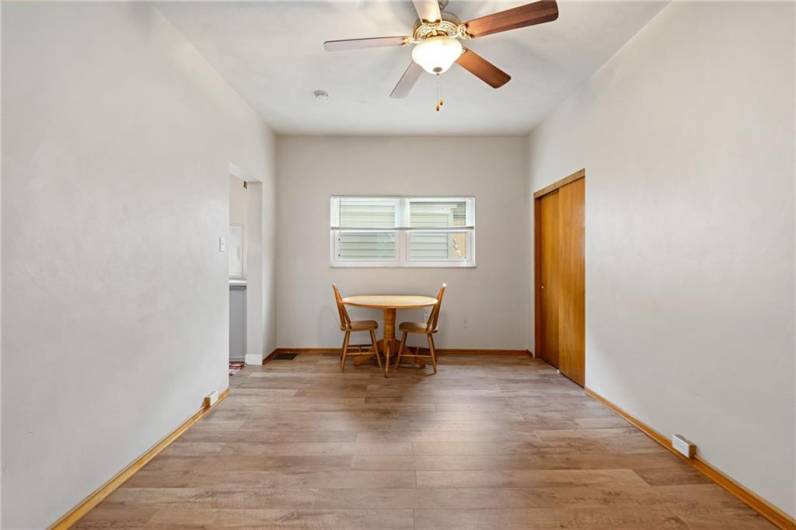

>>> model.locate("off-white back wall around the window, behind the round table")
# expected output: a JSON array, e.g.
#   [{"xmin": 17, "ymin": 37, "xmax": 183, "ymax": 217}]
[{"xmin": 276, "ymin": 136, "xmax": 530, "ymax": 349}]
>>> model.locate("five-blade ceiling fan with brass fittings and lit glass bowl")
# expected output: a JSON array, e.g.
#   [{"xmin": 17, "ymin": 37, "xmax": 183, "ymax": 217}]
[{"xmin": 323, "ymin": 0, "xmax": 558, "ymax": 98}]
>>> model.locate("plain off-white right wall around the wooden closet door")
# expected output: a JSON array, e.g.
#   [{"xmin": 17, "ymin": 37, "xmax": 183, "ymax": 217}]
[{"xmin": 529, "ymin": 2, "xmax": 796, "ymax": 515}]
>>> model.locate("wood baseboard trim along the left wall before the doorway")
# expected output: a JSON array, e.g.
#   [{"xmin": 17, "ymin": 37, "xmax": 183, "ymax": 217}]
[{"xmin": 49, "ymin": 388, "xmax": 229, "ymax": 530}]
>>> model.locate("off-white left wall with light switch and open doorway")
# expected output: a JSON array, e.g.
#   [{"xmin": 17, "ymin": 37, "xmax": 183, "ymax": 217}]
[{"xmin": 2, "ymin": 2, "xmax": 274, "ymax": 528}]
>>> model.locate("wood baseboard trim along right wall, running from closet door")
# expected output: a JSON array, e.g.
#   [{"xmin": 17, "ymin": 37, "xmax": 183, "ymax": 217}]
[{"xmin": 583, "ymin": 388, "xmax": 796, "ymax": 529}]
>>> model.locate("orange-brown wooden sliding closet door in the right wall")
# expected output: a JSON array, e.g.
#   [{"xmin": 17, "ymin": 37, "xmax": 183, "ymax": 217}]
[{"xmin": 535, "ymin": 171, "xmax": 586, "ymax": 386}]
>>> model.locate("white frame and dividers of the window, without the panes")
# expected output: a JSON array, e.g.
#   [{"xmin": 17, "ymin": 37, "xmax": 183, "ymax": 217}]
[{"xmin": 329, "ymin": 195, "xmax": 476, "ymax": 269}]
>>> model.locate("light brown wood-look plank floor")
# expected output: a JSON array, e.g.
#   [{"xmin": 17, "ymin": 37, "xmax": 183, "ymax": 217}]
[{"xmin": 77, "ymin": 354, "xmax": 772, "ymax": 530}]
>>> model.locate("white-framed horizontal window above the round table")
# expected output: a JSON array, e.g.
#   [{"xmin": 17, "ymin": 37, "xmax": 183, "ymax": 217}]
[{"xmin": 330, "ymin": 197, "xmax": 475, "ymax": 267}]
